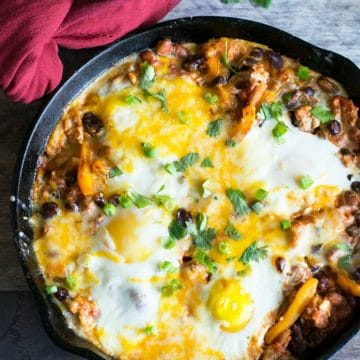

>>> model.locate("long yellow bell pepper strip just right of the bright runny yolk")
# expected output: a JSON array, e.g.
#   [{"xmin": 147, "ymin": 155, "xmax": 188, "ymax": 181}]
[{"xmin": 265, "ymin": 278, "xmax": 318, "ymax": 344}]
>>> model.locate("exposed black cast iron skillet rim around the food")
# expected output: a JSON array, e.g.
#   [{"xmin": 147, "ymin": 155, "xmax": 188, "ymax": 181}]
[{"xmin": 11, "ymin": 17, "xmax": 360, "ymax": 359}]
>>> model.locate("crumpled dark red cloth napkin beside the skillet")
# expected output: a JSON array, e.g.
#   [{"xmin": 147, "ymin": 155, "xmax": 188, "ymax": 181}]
[{"xmin": 0, "ymin": 0, "xmax": 180, "ymax": 103}]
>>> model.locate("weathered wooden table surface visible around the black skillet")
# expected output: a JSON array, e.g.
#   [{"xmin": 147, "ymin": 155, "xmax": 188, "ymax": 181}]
[{"xmin": 0, "ymin": 0, "xmax": 360, "ymax": 360}]
